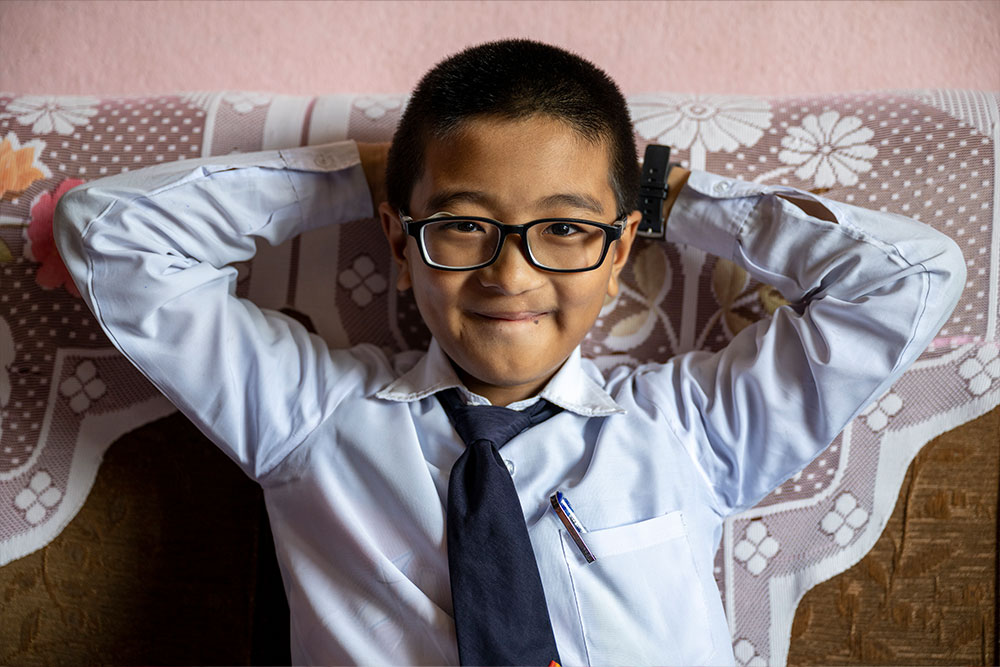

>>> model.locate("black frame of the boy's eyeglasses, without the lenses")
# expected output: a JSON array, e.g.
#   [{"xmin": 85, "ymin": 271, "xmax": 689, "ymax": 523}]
[{"xmin": 398, "ymin": 211, "xmax": 628, "ymax": 273}]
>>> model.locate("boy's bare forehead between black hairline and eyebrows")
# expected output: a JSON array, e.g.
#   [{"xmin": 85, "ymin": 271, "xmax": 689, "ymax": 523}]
[{"xmin": 410, "ymin": 116, "xmax": 615, "ymax": 217}]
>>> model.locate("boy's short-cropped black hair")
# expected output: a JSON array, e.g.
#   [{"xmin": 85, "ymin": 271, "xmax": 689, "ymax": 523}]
[{"xmin": 386, "ymin": 39, "xmax": 639, "ymax": 216}]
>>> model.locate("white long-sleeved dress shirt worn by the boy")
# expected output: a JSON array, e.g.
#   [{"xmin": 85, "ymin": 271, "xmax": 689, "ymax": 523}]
[{"xmin": 56, "ymin": 142, "xmax": 964, "ymax": 665}]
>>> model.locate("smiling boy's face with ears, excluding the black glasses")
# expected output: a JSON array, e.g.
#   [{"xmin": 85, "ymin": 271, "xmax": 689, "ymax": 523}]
[{"xmin": 379, "ymin": 116, "xmax": 639, "ymax": 405}]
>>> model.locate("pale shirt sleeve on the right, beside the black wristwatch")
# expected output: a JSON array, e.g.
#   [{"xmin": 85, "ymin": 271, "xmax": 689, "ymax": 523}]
[{"xmin": 648, "ymin": 172, "xmax": 965, "ymax": 514}]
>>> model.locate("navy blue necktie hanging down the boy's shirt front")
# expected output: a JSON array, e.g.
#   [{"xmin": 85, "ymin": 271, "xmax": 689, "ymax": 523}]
[{"xmin": 437, "ymin": 389, "xmax": 562, "ymax": 666}]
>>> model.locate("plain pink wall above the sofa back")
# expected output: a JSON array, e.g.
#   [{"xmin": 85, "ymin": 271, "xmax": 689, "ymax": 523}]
[{"xmin": 0, "ymin": 0, "xmax": 1000, "ymax": 94}]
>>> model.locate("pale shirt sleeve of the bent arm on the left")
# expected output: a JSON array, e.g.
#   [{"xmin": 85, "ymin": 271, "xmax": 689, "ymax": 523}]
[{"xmin": 55, "ymin": 142, "xmax": 380, "ymax": 478}]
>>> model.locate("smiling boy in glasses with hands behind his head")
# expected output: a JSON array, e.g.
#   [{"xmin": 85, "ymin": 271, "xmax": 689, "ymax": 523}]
[{"xmin": 57, "ymin": 40, "xmax": 964, "ymax": 664}]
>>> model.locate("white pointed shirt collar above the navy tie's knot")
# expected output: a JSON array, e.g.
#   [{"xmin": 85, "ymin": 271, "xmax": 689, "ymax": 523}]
[{"xmin": 375, "ymin": 339, "xmax": 625, "ymax": 417}]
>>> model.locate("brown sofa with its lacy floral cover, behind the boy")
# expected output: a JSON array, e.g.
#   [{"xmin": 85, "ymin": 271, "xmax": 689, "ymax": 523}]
[{"xmin": 0, "ymin": 89, "xmax": 1000, "ymax": 665}]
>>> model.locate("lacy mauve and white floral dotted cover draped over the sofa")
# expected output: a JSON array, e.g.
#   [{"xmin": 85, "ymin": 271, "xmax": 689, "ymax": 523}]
[{"xmin": 0, "ymin": 90, "xmax": 1000, "ymax": 665}]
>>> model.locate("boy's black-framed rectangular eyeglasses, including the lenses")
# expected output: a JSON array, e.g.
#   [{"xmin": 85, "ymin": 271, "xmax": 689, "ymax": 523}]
[{"xmin": 399, "ymin": 212, "xmax": 627, "ymax": 273}]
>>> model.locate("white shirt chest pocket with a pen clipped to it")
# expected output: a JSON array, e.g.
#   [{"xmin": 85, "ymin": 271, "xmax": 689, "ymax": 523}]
[{"xmin": 562, "ymin": 512, "xmax": 713, "ymax": 665}]
